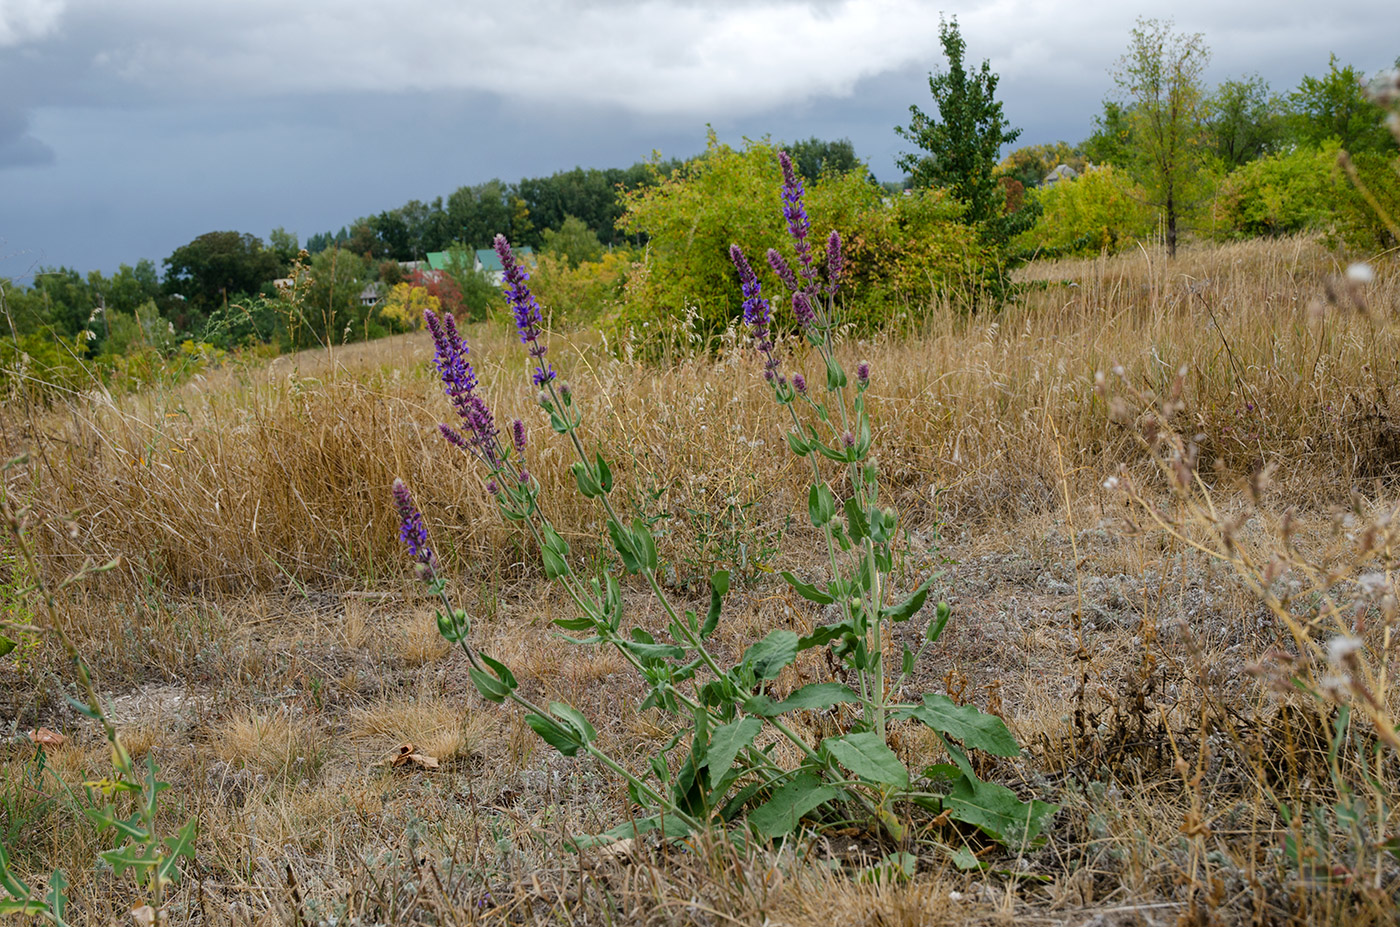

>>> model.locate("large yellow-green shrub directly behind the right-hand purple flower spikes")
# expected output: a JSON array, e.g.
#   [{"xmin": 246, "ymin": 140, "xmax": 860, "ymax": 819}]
[{"xmin": 609, "ymin": 133, "xmax": 1002, "ymax": 354}]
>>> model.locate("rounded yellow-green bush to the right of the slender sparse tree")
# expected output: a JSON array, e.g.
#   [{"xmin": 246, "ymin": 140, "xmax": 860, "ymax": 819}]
[{"xmin": 1212, "ymin": 143, "xmax": 1345, "ymax": 238}]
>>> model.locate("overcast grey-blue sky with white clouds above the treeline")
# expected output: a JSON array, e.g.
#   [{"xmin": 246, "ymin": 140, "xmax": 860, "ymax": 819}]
[{"xmin": 0, "ymin": 0, "xmax": 1400, "ymax": 280}]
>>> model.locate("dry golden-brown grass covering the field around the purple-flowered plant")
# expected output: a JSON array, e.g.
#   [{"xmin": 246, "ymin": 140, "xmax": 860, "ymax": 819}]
[{"xmin": 0, "ymin": 239, "xmax": 1400, "ymax": 924}]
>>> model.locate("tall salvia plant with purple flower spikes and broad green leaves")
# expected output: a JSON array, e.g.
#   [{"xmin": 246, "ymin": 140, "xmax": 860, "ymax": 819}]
[{"xmin": 393, "ymin": 153, "xmax": 1057, "ymax": 868}]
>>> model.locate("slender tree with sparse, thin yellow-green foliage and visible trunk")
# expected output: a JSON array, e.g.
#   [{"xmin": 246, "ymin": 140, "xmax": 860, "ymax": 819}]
[{"xmin": 1113, "ymin": 18, "xmax": 1211, "ymax": 258}]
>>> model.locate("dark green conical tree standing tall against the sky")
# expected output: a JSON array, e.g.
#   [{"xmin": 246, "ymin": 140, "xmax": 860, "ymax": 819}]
[{"xmin": 895, "ymin": 18, "xmax": 1021, "ymax": 241}]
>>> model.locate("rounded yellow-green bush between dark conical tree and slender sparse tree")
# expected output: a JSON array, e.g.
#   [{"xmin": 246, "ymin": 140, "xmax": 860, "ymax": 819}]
[{"xmin": 1016, "ymin": 164, "xmax": 1152, "ymax": 256}]
